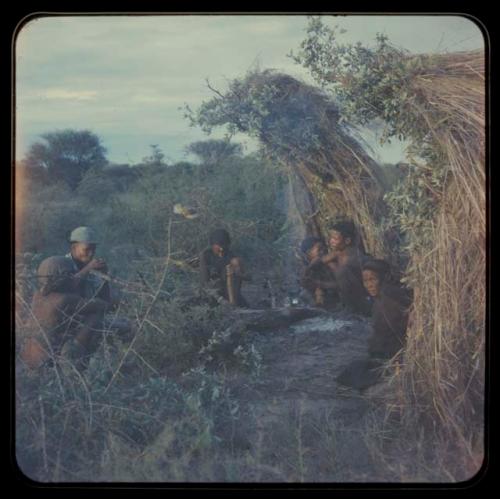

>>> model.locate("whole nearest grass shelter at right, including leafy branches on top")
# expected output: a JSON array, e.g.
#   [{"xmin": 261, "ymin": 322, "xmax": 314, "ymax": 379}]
[{"xmin": 293, "ymin": 18, "xmax": 486, "ymax": 480}]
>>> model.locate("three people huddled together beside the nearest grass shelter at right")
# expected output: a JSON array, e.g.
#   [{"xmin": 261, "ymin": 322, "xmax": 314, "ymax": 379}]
[{"xmin": 301, "ymin": 222, "xmax": 412, "ymax": 389}]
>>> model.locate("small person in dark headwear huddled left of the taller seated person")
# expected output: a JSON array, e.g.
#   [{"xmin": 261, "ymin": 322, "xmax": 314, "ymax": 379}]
[{"xmin": 300, "ymin": 236, "xmax": 338, "ymax": 309}]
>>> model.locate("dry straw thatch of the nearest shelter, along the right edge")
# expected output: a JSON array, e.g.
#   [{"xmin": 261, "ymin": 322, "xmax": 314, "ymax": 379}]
[{"xmin": 388, "ymin": 51, "xmax": 486, "ymax": 478}]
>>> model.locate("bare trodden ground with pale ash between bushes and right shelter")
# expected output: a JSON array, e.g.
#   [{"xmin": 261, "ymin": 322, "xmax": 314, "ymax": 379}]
[{"xmin": 213, "ymin": 312, "xmax": 388, "ymax": 482}]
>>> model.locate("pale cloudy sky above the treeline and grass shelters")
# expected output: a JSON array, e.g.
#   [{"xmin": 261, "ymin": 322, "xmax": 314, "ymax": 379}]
[{"xmin": 15, "ymin": 15, "xmax": 484, "ymax": 164}]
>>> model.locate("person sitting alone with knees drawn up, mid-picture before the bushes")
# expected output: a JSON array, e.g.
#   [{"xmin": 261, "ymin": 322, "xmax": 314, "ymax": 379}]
[{"xmin": 200, "ymin": 229, "xmax": 248, "ymax": 307}]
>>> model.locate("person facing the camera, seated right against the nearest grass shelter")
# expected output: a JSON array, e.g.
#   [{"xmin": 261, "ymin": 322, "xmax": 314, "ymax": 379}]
[{"xmin": 337, "ymin": 259, "xmax": 412, "ymax": 390}]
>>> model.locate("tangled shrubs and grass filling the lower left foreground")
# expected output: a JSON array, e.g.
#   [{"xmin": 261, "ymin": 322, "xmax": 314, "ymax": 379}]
[{"xmin": 16, "ymin": 261, "xmax": 260, "ymax": 482}]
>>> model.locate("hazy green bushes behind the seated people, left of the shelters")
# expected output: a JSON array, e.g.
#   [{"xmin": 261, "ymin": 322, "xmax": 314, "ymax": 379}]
[{"xmin": 16, "ymin": 139, "xmax": 285, "ymax": 266}]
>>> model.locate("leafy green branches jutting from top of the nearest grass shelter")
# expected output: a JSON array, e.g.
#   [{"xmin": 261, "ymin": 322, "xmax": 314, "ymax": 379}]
[{"xmin": 290, "ymin": 16, "xmax": 423, "ymax": 140}]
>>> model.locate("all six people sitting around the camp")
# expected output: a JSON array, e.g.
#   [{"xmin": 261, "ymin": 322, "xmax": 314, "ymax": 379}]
[{"xmin": 22, "ymin": 222, "xmax": 411, "ymax": 386}]
